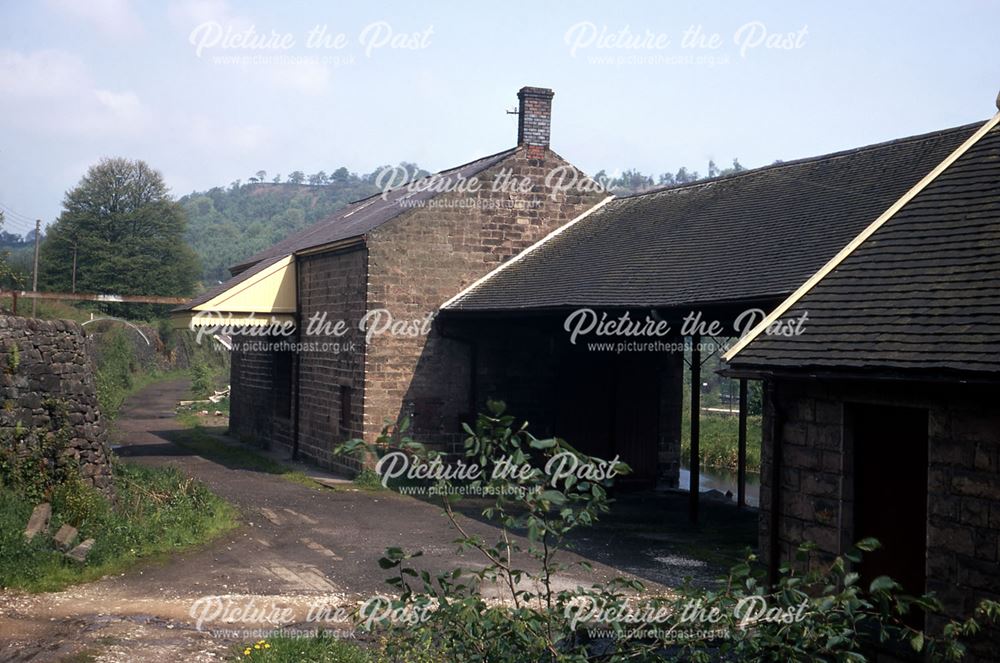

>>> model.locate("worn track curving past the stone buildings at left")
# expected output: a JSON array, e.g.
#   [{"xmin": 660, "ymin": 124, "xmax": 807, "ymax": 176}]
[{"xmin": 0, "ymin": 381, "xmax": 656, "ymax": 661}]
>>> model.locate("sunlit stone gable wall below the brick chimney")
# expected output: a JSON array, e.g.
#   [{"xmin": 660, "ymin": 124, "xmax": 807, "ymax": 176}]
[{"xmin": 364, "ymin": 149, "xmax": 605, "ymax": 444}]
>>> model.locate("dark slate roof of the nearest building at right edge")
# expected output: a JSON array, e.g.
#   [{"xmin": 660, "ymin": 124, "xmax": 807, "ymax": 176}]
[{"xmin": 730, "ymin": 119, "xmax": 1000, "ymax": 377}]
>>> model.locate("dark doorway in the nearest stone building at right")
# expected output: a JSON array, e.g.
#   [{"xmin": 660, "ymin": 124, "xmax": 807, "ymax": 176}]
[{"xmin": 848, "ymin": 405, "xmax": 927, "ymax": 626}]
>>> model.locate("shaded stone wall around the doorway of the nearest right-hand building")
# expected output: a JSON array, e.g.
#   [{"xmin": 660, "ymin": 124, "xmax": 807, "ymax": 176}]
[{"xmin": 760, "ymin": 379, "xmax": 1000, "ymax": 660}]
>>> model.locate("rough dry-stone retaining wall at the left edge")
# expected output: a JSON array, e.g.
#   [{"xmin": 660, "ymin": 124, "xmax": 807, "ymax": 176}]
[{"xmin": 0, "ymin": 316, "xmax": 113, "ymax": 494}]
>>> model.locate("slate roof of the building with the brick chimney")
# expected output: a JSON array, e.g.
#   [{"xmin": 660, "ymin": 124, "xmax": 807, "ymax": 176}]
[{"xmin": 174, "ymin": 147, "xmax": 518, "ymax": 311}]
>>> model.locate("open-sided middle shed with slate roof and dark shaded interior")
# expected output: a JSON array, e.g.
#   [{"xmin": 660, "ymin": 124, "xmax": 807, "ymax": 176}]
[{"xmin": 440, "ymin": 119, "xmax": 979, "ymax": 490}]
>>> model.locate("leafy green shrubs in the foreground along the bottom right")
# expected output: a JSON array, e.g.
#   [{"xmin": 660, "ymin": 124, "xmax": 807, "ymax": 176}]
[{"xmin": 336, "ymin": 403, "xmax": 1000, "ymax": 663}]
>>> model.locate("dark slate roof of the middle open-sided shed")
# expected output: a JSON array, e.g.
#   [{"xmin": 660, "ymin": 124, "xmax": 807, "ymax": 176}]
[{"xmin": 446, "ymin": 123, "xmax": 981, "ymax": 313}]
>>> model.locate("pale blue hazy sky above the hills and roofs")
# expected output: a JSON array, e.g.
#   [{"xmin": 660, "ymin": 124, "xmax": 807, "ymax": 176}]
[{"xmin": 0, "ymin": 0, "xmax": 1000, "ymax": 232}]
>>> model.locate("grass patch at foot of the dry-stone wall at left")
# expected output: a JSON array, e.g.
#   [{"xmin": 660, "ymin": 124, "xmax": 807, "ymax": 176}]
[{"xmin": 0, "ymin": 463, "xmax": 237, "ymax": 592}]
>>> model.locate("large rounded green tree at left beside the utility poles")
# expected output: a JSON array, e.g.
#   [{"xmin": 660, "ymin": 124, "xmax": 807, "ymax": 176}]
[{"xmin": 39, "ymin": 158, "xmax": 200, "ymax": 317}]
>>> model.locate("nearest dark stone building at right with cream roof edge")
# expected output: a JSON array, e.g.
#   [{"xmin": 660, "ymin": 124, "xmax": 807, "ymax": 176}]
[{"xmin": 727, "ymin": 114, "xmax": 1000, "ymax": 660}]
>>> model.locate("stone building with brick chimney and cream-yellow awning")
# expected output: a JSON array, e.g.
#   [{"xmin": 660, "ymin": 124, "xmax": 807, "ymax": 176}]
[{"xmin": 178, "ymin": 87, "xmax": 607, "ymax": 472}]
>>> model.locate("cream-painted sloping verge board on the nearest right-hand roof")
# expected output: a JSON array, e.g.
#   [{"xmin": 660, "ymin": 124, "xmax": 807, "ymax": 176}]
[{"xmin": 722, "ymin": 113, "xmax": 1000, "ymax": 362}]
